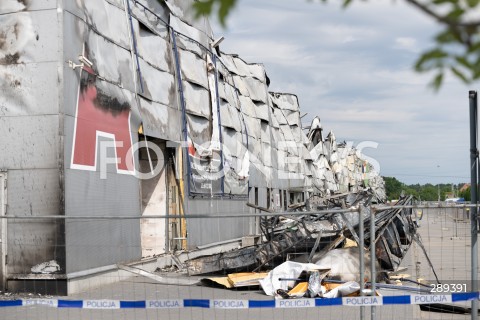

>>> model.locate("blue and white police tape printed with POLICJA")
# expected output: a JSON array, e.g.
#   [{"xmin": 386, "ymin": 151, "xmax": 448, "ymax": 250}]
[{"xmin": 0, "ymin": 292, "xmax": 480, "ymax": 309}]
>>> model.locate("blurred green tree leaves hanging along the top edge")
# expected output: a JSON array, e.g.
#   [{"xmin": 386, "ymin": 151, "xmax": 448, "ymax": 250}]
[{"xmin": 188, "ymin": 0, "xmax": 480, "ymax": 89}]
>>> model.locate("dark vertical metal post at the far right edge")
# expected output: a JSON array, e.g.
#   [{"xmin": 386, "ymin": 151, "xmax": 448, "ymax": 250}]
[{"xmin": 468, "ymin": 90, "xmax": 478, "ymax": 320}]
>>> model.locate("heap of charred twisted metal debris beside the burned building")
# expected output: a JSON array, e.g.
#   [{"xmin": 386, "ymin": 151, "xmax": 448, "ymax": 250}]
[{"xmin": 186, "ymin": 191, "xmax": 416, "ymax": 289}]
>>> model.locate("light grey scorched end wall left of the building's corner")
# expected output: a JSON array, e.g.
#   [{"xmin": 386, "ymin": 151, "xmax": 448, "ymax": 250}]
[{"xmin": 0, "ymin": 0, "xmax": 65, "ymax": 276}]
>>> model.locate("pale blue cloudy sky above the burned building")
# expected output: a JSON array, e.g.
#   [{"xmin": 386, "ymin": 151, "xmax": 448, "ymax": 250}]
[{"xmin": 213, "ymin": 0, "xmax": 478, "ymax": 184}]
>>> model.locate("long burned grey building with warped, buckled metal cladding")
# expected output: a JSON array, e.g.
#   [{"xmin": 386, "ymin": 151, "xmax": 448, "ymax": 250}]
[{"xmin": 0, "ymin": 0, "xmax": 384, "ymax": 292}]
